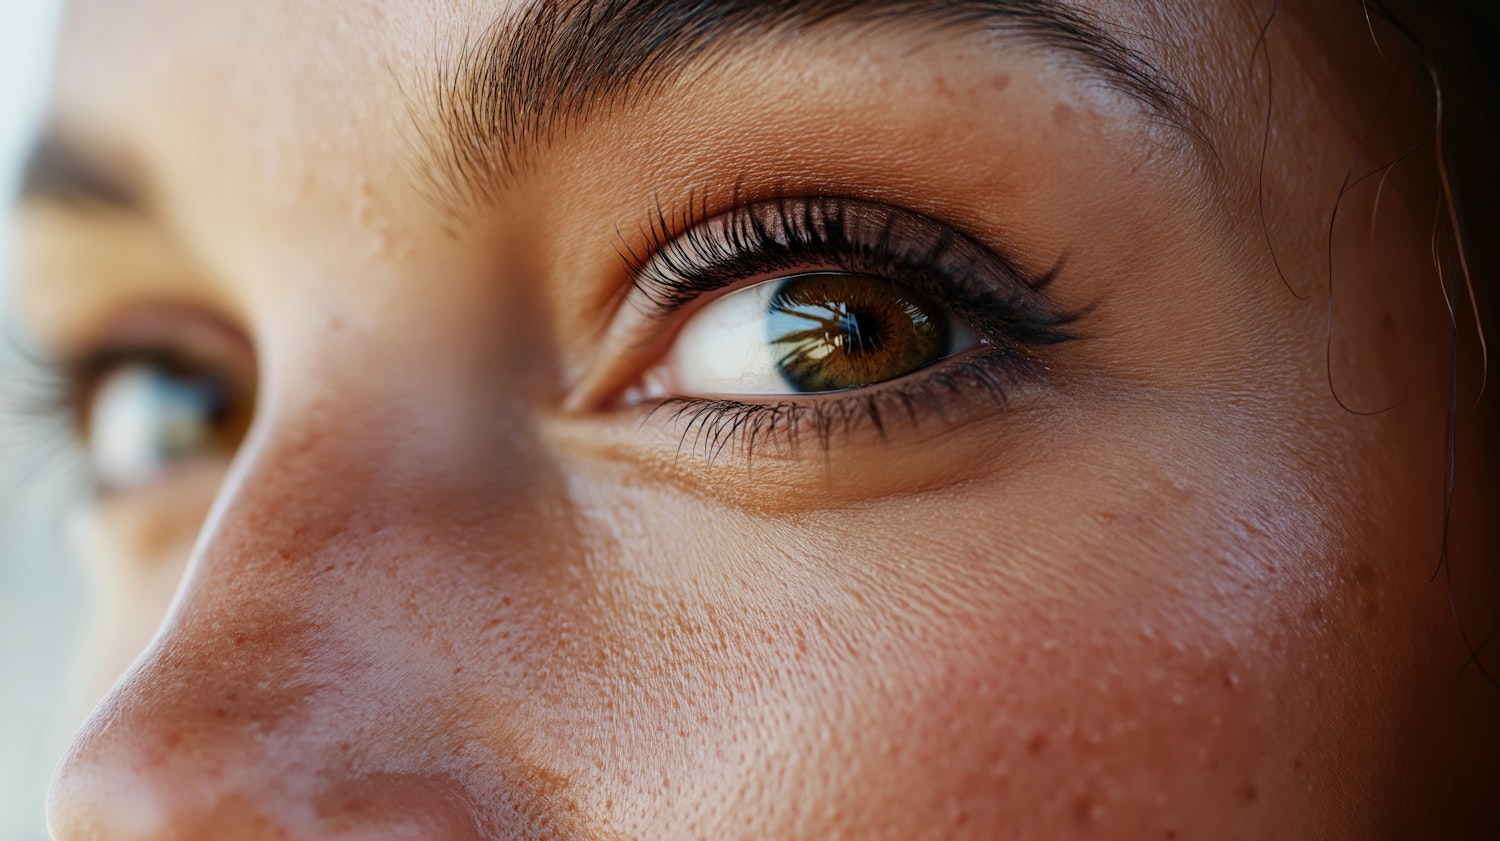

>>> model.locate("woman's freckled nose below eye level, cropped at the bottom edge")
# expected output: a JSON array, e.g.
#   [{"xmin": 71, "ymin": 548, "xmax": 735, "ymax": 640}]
[{"xmin": 48, "ymin": 389, "xmax": 578, "ymax": 841}]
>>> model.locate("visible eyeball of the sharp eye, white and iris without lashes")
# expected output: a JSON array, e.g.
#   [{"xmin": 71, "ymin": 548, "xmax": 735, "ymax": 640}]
[{"xmin": 641, "ymin": 271, "xmax": 984, "ymax": 397}]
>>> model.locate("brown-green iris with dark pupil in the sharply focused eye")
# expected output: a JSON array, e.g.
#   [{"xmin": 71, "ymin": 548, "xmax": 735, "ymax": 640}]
[{"xmin": 768, "ymin": 273, "xmax": 950, "ymax": 393}]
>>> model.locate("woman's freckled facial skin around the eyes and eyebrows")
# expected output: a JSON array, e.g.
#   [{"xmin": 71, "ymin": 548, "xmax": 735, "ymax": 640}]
[{"xmin": 14, "ymin": 0, "xmax": 1500, "ymax": 840}]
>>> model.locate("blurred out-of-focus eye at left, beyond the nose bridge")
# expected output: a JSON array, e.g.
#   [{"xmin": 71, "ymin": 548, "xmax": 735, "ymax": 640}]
[{"xmin": 83, "ymin": 357, "xmax": 249, "ymax": 490}]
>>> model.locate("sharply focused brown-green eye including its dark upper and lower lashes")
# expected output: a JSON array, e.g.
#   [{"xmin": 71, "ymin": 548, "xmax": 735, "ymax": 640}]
[{"xmin": 591, "ymin": 196, "xmax": 1082, "ymax": 462}]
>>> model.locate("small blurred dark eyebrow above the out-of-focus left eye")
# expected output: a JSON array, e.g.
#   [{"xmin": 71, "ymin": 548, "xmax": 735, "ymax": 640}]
[{"xmin": 18, "ymin": 130, "xmax": 146, "ymax": 213}]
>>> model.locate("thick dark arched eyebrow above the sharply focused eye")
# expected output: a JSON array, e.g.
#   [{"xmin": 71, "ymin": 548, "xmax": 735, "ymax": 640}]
[{"xmin": 413, "ymin": 0, "xmax": 1203, "ymax": 207}]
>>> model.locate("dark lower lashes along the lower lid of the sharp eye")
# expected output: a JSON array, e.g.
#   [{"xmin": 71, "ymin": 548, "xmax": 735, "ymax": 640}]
[{"xmin": 642, "ymin": 348, "xmax": 1041, "ymax": 465}]
